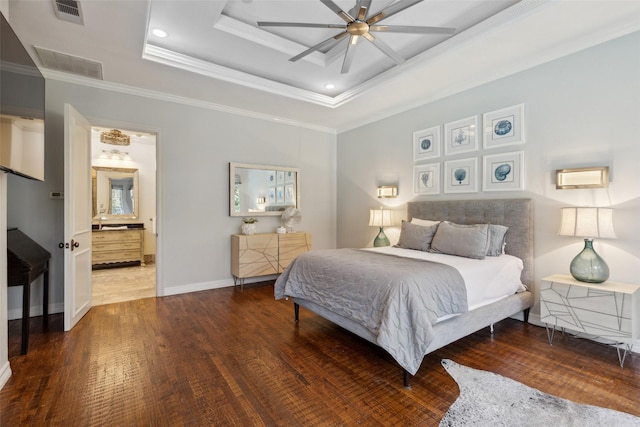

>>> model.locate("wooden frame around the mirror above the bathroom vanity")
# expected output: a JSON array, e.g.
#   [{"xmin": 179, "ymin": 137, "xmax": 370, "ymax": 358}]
[{"xmin": 91, "ymin": 166, "xmax": 140, "ymax": 221}]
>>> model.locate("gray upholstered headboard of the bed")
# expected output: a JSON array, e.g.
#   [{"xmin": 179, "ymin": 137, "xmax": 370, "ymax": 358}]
[{"xmin": 407, "ymin": 199, "xmax": 533, "ymax": 289}]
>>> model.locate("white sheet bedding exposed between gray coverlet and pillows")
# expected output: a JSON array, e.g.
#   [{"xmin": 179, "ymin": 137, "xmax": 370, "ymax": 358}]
[{"xmin": 367, "ymin": 246, "xmax": 526, "ymax": 312}]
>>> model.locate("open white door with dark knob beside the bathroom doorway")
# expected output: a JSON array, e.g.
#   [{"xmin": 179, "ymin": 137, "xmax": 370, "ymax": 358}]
[{"xmin": 63, "ymin": 104, "xmax": 91, "ymax": 331}]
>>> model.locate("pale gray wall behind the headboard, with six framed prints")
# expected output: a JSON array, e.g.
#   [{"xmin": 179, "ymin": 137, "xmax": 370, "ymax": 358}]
[{"xmin": 337, "ymin": 33, "xmax": 640, "ymax": 318}]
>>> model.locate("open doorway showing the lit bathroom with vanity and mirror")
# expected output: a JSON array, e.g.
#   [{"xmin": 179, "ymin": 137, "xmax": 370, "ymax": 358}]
[{"xmin": 91, "ymin": 126, "xmax": 157, "ymax": 306}]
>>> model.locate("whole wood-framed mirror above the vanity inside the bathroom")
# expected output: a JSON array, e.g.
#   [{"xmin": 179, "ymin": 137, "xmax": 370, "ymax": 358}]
[{"xmin": 91, "ymin": 166, "xmax": 140, "ymax": 220}]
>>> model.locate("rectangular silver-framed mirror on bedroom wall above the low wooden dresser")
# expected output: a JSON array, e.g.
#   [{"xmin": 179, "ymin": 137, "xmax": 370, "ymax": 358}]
[{"xmin": 229, "ymin": 163, "xmax": 300, "ymax": 217}]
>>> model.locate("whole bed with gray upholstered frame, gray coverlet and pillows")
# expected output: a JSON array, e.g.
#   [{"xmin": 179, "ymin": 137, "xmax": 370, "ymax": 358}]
[{"xmin": 274, "ymin": 199, "xmax": 533, "ymax": 387}]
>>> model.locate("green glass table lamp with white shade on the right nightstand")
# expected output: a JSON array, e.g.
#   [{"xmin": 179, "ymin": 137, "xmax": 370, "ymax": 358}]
[{"xmin": 558, "ymin": 208, "xmax": 616, "ymax": 283}]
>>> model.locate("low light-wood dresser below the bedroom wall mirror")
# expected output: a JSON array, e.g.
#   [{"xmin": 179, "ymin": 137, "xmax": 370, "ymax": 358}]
[{"xmin": 231, "ymin": 232, "xmax": 311, "ymax": 285}]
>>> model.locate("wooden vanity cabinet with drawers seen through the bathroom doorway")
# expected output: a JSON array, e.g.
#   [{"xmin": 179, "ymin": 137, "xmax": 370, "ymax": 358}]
[{"xmin": 91, "ymin": 228, "xmax": 144, "ymax": 267}]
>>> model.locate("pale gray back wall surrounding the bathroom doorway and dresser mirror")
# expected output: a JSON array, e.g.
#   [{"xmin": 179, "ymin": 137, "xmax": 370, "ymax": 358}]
[{"xmin": 8, "ymin": 80, "xmax": 336, "ymax": 318}]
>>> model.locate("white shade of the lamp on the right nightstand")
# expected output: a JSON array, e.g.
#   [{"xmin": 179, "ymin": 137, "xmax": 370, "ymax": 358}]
[{"xmin": 558, "ymin": 208, "xmax": 616, "ymax": 239}]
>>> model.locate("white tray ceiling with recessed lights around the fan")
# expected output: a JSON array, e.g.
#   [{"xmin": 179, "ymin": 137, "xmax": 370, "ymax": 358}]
[{"xmin": 9, "ymin": 0, "xmax": 640, "ymax": 131}]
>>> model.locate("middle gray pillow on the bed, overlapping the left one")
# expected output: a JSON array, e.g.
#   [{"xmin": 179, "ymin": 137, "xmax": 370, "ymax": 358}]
[{"xmin": 431, "ymin": 221, "xmax": 489, "ymax": 259}]
